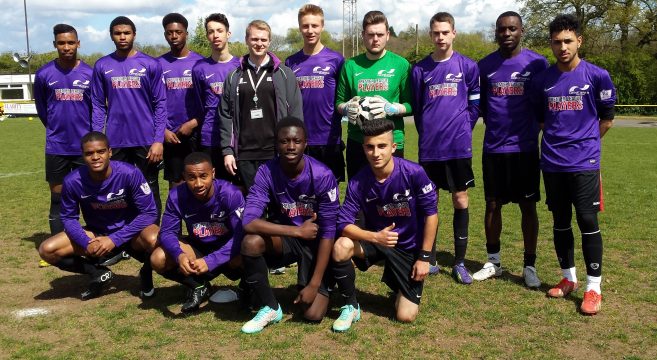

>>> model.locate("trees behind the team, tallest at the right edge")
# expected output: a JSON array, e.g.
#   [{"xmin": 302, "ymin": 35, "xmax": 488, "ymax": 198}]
[{"xmin": 0, "ymin": 0, "xmax": 657, "ymax": 114}]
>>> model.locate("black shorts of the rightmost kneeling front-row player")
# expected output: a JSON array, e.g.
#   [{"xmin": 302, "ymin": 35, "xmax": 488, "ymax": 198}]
[{"xmin": 352, "ymin": 241, "xmax": 424, "ymax": 305}]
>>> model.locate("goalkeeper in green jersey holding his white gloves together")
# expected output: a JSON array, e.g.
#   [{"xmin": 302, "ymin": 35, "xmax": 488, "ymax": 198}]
[{"xmin": 335, "ymin": 11, "xmax": 411, "ymax": 179}]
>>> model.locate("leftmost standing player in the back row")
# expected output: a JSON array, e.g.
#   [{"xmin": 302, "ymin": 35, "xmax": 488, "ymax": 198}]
[{"xmin": 34, "ymin": 24, "xmax": 92, "ymax": 239}]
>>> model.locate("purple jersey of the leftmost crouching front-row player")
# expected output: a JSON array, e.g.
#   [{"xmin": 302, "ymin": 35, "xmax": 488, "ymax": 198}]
[{"xmin": 60, "ymin": 161, "xmax": 157, "ymax": 248}]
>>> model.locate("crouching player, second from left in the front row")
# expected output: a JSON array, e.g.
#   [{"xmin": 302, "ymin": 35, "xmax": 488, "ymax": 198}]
[{"xmin": 151, "ymin": 152, "xmax": 244, "ymax": 313}]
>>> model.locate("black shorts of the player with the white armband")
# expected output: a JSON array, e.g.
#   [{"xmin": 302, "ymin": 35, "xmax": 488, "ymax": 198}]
[{"xmin": 420, "ymin": 158, "xmax": 475, "ymax": 193}]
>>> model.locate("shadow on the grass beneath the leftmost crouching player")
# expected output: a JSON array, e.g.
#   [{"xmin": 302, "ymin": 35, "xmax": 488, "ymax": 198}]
[{"xmin": 34, "ymin": 274, "xmax": 139, "ymax": 300}]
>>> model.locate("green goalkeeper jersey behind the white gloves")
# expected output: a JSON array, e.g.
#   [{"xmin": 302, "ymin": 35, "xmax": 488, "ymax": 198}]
[{"xmin": 335, "ymin": 51, "xmax": 411, "ymax": 149}]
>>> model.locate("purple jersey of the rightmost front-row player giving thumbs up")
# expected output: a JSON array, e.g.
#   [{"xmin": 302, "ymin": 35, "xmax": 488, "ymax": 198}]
[{"xmin": 337, "ymin": 157, "xmax": 438, "ymax": 251}]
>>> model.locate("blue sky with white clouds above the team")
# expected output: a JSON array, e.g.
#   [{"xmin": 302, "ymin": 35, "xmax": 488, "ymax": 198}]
[{"xmin": 0, "ymin": 0, "xmax": 520, "ymax": 54}]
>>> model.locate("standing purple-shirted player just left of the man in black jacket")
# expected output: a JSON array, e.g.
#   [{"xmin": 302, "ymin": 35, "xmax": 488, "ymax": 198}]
[{"xmin": 192, "ymin": 13, "xmax": 240, "ymax": 179}]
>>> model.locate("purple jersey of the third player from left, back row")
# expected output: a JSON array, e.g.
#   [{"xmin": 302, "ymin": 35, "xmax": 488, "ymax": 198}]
[{"xmin": 157, "ymin": 51, "xmax": 203, "ymax": 132}]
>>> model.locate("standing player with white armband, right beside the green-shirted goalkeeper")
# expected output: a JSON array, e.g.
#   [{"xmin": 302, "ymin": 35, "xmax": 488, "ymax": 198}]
[{"xmin": 411, "ymin": 12, "xmax": 479, "ymax": 284}]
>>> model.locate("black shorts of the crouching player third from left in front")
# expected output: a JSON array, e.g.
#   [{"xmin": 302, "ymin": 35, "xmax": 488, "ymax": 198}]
[{"xmin": 265, "ymin": 237, "xmax": 329, "ymax": 297}]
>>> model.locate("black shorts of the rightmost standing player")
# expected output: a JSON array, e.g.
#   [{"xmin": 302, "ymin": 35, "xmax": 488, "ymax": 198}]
[{"xmin": 543, "ymin": 170, "xmax": 601, "ymax": 213}]
